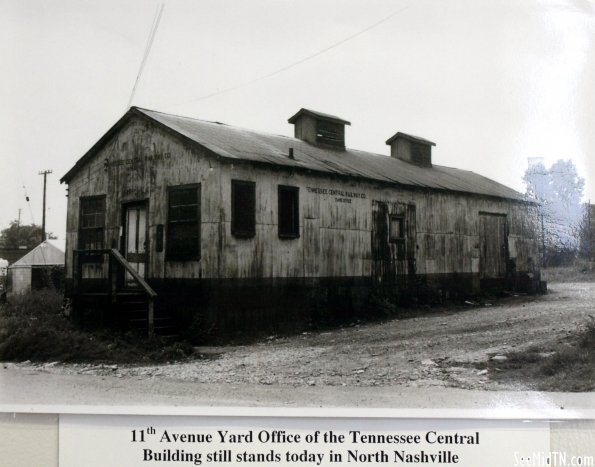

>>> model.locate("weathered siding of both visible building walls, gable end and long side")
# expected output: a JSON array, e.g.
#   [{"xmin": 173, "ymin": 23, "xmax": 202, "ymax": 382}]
[{"xmin": 66, "ymin": 118, "xmax": 536, "ymax": 286}]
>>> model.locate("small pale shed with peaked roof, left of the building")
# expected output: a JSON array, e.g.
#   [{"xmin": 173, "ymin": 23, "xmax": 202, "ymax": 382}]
[{"xmin": 7, "ymin": 240, "xmax": 64, "ymax": 294}]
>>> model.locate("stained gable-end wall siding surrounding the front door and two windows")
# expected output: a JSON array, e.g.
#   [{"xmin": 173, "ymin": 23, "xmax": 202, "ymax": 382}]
[{"xmin": 66, "ymin": 119, "xmax": 221, "ymax": 284}]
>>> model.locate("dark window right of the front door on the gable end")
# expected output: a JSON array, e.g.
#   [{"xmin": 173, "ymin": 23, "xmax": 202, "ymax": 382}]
[{"xmin": 165, "ymin": 185, "xmax": 200, "ymax": 261}]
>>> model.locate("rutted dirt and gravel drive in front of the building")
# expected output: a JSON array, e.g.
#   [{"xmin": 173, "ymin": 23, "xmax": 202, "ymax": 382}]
[{"xmin": 3, "ymin": 283, "xmax": 595, "ymax": 397}]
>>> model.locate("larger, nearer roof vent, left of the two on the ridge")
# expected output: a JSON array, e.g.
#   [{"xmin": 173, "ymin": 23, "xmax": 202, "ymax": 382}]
[{"xmin": 288, "ymin": 109, "xmax": 351, "ymax": 149}]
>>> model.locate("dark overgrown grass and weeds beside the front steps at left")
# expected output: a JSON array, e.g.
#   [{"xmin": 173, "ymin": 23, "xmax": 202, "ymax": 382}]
[{"xmin": 0, "ymin": 290, "xmax": 192, "ymax": 363}]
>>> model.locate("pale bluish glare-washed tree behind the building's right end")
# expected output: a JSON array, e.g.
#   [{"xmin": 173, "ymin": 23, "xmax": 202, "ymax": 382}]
[{"xmin": 523, "ymin": 159, "xmax": 585, "ymax": 266}]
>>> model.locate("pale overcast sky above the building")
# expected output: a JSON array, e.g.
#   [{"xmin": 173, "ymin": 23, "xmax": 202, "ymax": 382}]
[{"xmin": 0, "ymin": 0, "xmax": 595, "ymax": 247}]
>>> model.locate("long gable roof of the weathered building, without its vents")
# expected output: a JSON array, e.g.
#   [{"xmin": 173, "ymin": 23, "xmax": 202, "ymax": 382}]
[{"xmin": 60, "ymin": 107, "xmax": 525, "ymax": 201}]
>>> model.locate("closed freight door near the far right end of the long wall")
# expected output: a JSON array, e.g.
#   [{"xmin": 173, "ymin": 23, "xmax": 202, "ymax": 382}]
[{"xmin": 479, "ymin": 213, "xmax": 508, "ymax": 279}]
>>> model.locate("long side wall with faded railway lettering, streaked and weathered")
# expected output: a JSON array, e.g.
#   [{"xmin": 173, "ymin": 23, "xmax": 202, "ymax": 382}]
[{"xmin": 212, "ymin": 165, "xmax": 537, "ymax": 284}]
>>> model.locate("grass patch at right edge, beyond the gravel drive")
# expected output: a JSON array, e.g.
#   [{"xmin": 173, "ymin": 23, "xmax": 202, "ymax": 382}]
[{"xmin": 488, "ymin": 317, "xmax": 595, "ymax": 392}]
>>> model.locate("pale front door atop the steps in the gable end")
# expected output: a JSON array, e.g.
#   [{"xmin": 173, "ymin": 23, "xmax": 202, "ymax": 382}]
[{"xmin": 124, "ymin": 203, "xmax": 147, "ymax": 286}]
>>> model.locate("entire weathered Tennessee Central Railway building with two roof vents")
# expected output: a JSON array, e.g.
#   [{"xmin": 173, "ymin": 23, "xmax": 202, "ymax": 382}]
[{"xmin": 61, "ymin": 107, "xmax": 539, "ymax": 335}]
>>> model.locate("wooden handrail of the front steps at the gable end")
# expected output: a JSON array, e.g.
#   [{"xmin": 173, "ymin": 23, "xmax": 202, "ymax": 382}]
[{"xmin": 73, "ymin": 248, "xmax": 157, "ymax": 337}]
